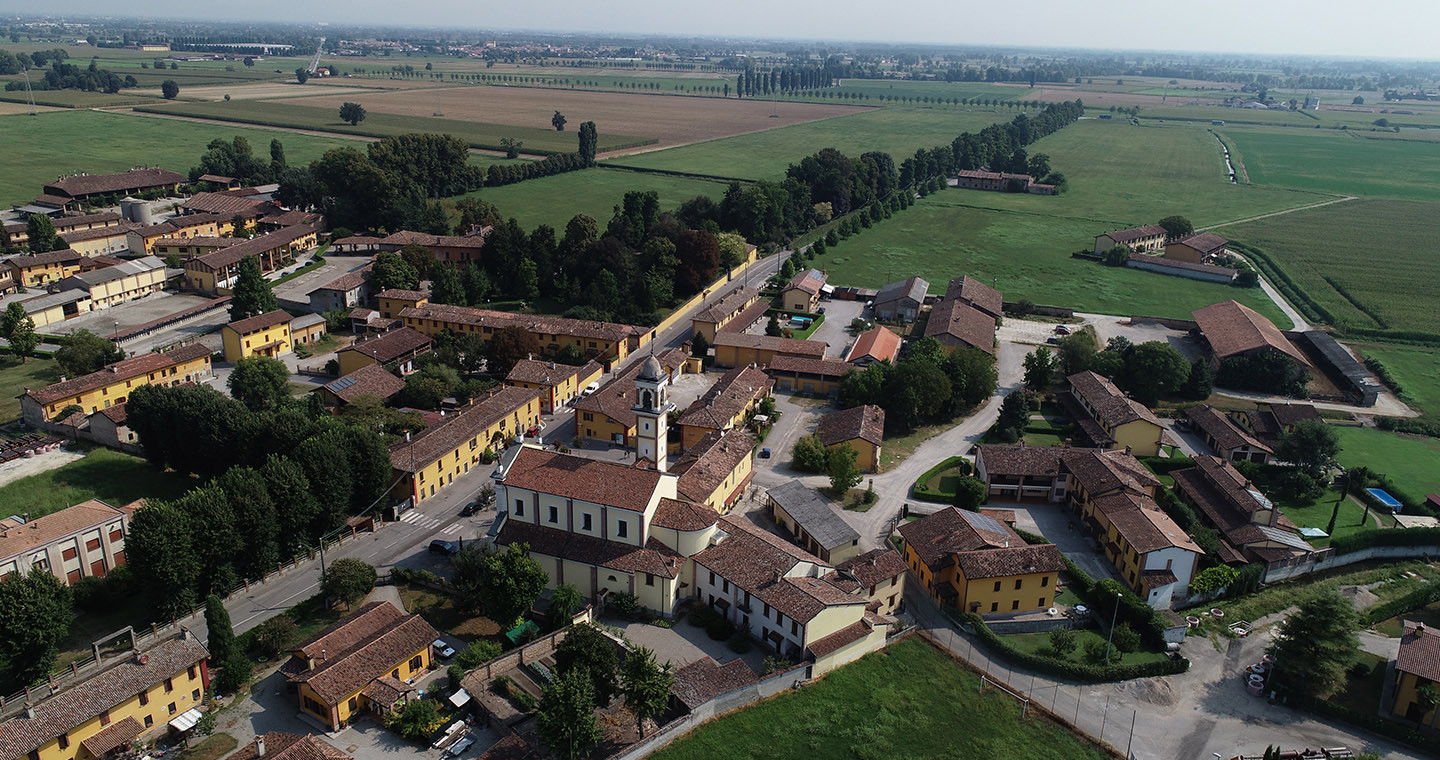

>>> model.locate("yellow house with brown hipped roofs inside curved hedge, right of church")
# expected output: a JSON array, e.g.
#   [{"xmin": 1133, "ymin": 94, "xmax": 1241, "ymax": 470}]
[{"xmin": 899, "ymin": 507, "xmax": 1066, "ymax": 616}]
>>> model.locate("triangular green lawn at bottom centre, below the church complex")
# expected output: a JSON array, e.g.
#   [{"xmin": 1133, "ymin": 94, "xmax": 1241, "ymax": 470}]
[{"xmin": 654, "ymin": 638, "xmax": 1104, "ymax": 760}]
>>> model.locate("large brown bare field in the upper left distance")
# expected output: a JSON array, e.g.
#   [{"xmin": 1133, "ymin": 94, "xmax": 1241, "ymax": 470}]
[{"xmin": 277, "ymin": 86, "xmax": 857, "ymax": 150}]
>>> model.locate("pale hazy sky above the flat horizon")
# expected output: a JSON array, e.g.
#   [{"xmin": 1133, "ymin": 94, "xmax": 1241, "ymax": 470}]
[{"xmin": 8, "ymin": 0, "xmax": 1440, "ymax": 59}]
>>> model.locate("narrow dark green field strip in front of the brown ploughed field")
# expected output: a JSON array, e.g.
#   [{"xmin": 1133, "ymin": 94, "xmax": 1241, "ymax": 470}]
[{"xmin": 141, "ymin": 100, "xmax": 651, "ymax": 153}]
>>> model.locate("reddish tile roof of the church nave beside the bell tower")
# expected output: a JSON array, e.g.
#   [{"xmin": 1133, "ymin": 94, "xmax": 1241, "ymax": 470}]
[{"xmin": 501, "ymin": 446, "xmax": 660, "ymax": 512}]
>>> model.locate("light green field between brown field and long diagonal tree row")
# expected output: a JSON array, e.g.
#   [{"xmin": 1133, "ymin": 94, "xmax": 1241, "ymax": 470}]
[{"xmin": 606, "ymin": 107, "xmax": 1017, "ymax": 180}]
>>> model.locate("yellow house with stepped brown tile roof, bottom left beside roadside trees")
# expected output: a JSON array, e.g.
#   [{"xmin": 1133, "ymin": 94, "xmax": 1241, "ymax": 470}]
[{"xmin": 281, "ymin": 602, "xmax": 439, "ymax": 731}]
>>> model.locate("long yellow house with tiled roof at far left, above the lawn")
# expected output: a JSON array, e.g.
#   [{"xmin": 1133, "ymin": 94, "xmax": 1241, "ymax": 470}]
[{"xmin": 20, "ymin": 343, "xmax": 210, "ymax": 426}]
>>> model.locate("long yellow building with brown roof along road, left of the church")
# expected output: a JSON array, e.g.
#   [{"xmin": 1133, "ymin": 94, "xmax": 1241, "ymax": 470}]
[{"xmin": 390, "ymin": 387, "xmax": 540, "ymax": 504}]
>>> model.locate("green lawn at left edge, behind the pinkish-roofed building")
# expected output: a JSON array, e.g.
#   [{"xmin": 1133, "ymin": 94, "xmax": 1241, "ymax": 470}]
[{"xmin": 0, "ymin": 449, "xmax": 196, "ymax": 518}]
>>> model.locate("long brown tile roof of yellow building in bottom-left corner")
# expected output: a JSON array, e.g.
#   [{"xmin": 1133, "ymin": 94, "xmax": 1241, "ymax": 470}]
[{"xmin": 0, "ymin": 636, "xmax": 210, "ymax": 757}]
